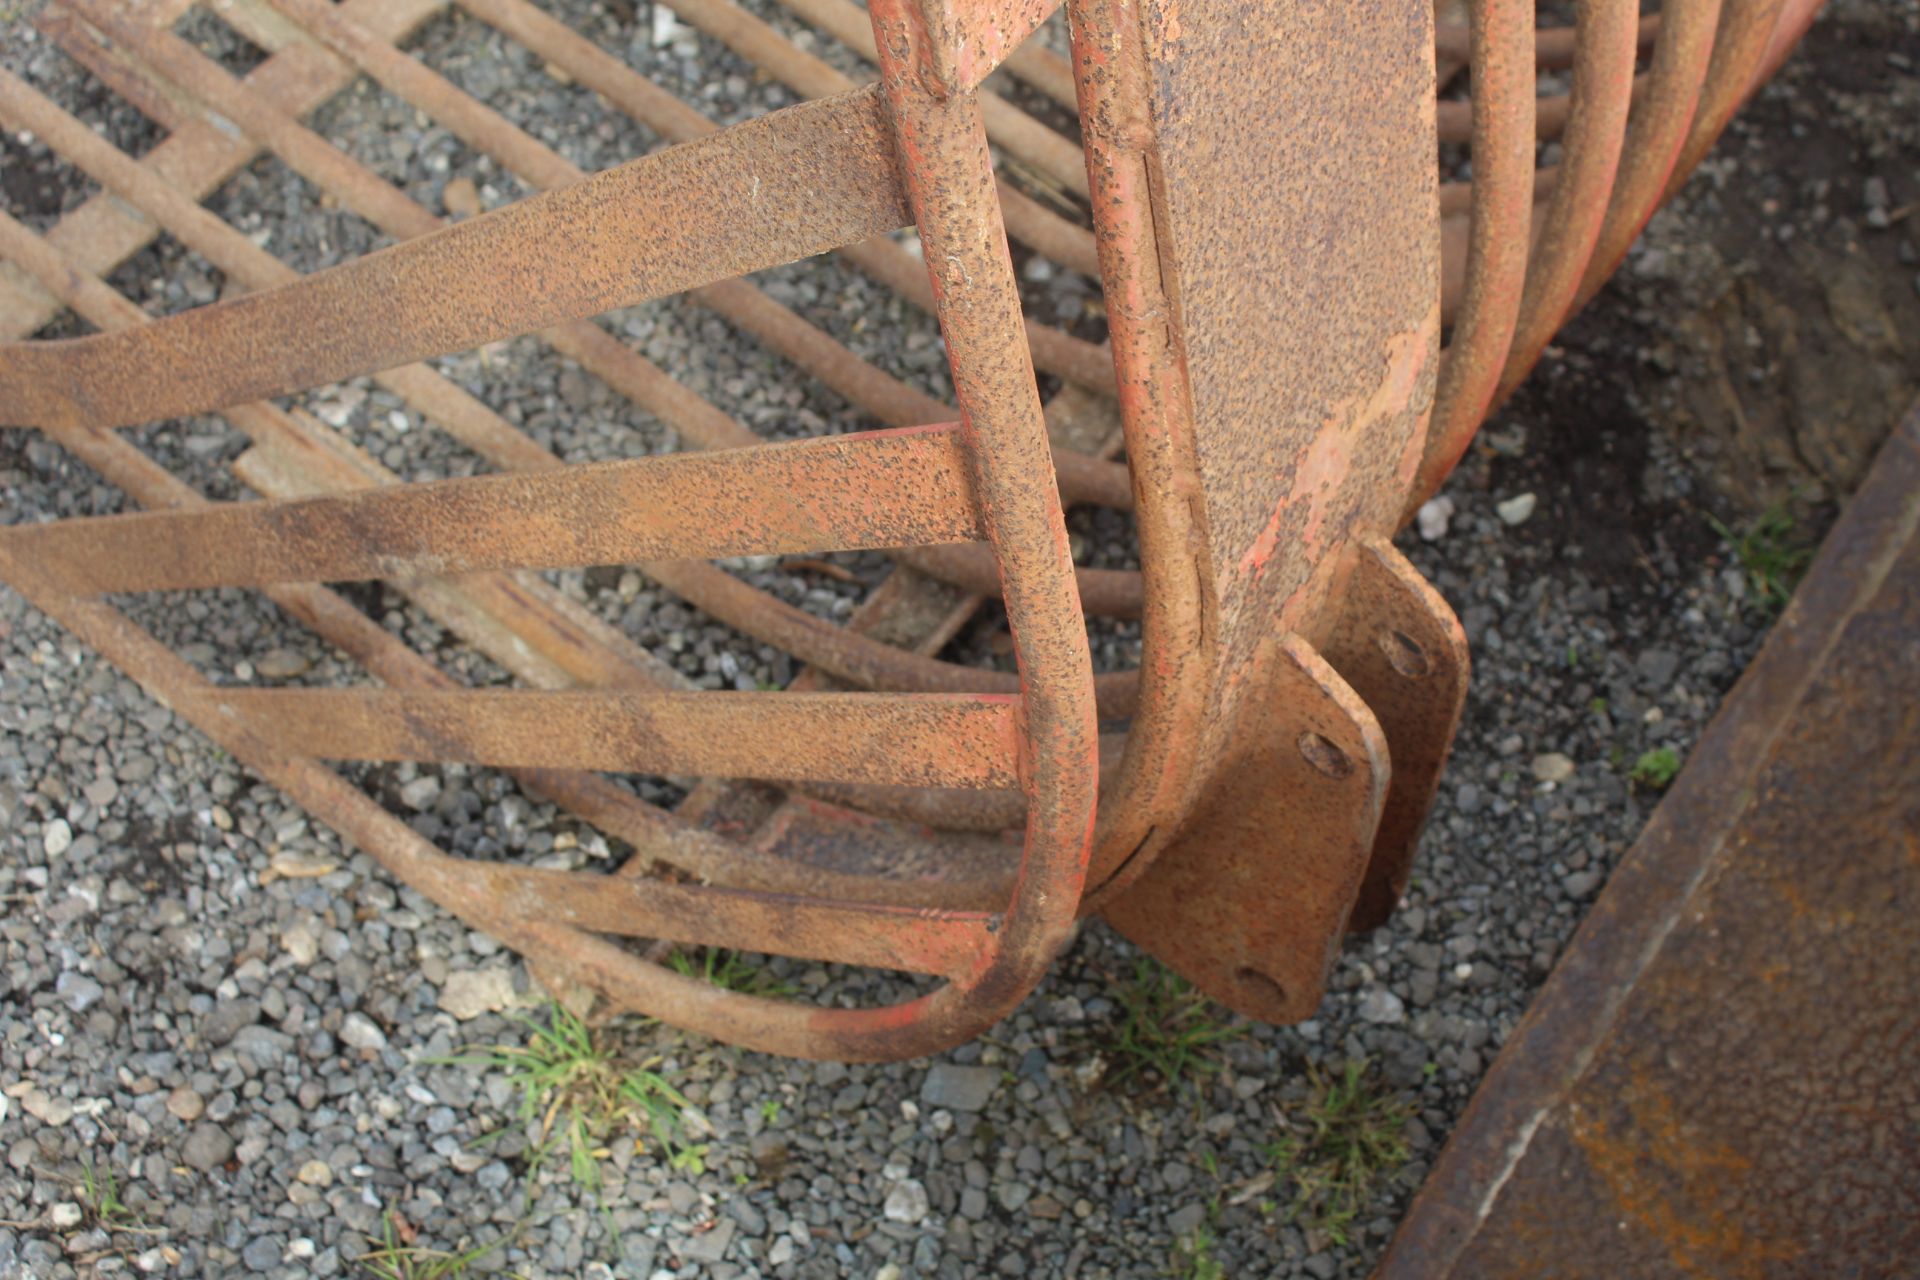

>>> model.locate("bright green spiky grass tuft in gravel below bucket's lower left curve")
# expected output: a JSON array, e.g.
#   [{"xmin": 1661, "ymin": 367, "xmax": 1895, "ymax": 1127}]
[{"xmin": 449, "ymin": 1002, "xmax": 687, "ymax": 1192}]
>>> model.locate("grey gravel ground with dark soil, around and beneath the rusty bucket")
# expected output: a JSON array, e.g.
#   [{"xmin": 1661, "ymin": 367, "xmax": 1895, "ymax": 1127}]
[{"xmin": 0, "ymin": 0, "xmax": 1920, "ymax": 1280}]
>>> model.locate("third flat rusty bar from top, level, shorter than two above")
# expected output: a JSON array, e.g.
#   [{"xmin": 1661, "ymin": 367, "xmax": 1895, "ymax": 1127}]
[{"xmin": 180, "ymin": 687, "xmax": 1020, "ymax": 787}]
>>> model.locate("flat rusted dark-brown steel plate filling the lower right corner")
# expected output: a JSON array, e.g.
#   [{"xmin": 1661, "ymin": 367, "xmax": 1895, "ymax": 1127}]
[{"xmin": 1380, "ymin": 405, "xmax": 1920, "ymax": 1280}]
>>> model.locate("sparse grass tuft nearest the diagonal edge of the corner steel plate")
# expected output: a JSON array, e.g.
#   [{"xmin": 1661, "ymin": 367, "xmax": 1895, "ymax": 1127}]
[{"xmin": 1267, "ymin": 1059, "xmax": 1413, "ymax": 1245}]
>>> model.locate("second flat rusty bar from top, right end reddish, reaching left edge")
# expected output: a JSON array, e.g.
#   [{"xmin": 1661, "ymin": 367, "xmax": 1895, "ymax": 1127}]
[{"xmin": 0, "ymin": 428, "xmax": 981, "ymax": 595}]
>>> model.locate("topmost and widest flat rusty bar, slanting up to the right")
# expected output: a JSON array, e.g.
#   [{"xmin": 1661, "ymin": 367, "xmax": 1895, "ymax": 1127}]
[{"xmin": 0, "ymin": 90, "xmax": 908, "ymax": 435}]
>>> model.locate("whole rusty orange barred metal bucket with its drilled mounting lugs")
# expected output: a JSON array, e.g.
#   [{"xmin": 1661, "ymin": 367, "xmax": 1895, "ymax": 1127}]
[{"xmin": 0, "ymin": 0, "xmax": 1816, "ymax": 1059}]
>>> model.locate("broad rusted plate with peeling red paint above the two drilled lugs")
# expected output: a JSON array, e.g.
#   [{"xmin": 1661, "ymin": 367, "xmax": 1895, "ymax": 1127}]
[{"xmin": 1139, "ymin": 0, "xmax": 1440, "ymax": 687}]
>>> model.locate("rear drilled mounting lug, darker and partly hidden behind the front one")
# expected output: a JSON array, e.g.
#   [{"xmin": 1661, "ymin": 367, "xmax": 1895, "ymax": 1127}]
[{"xmin": 1325, "ymin": 535, "xmax": 1469, "ymax": 929}]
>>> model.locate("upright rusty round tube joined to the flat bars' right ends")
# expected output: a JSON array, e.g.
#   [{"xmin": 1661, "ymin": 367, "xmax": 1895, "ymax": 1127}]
[{"xmin": 872, "ymin": 0, "xmax": 1098, "ymax": 1011}]
